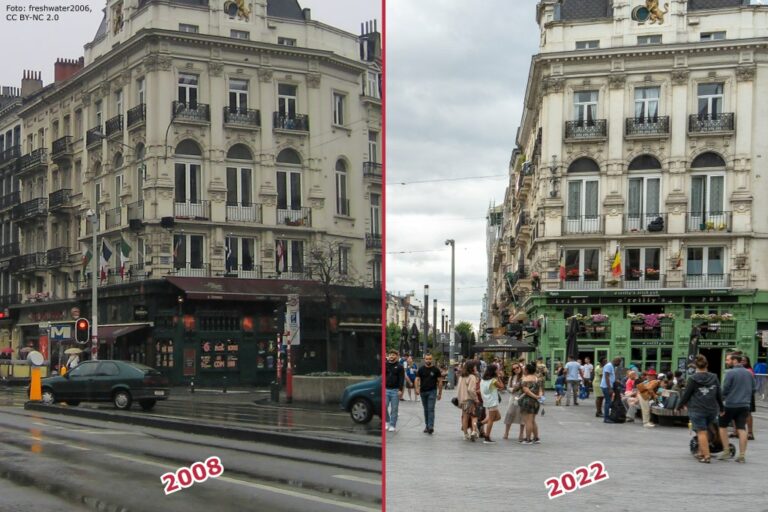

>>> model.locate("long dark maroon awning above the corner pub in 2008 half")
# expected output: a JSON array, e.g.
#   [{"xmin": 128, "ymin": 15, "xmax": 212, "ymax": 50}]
[{"xmin": 166, "ymin": 277, "xmax": 320, "ymax": 301}]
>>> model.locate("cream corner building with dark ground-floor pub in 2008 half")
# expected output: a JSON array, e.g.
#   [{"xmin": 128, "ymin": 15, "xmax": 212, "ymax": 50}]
[{"xmin": 0, "ymin": 0, "xmax": 382, "ymax": 384}]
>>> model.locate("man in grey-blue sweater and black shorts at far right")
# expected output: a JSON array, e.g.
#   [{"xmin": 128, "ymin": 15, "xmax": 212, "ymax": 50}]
[{"xmin": 718, "ymin": 353, "xmax": 757, "ymax": 462}]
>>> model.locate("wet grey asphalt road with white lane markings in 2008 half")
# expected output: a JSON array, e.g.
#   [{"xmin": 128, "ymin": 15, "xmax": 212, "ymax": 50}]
[{"xmin": 0, "ymin": 390, "xmax": 381, "ymax": 512}]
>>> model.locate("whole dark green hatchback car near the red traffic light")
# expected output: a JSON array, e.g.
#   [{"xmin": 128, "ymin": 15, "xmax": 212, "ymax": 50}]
[{"xmin": 42, "ymin": 360, "xmax": 170, "ymax": 411}]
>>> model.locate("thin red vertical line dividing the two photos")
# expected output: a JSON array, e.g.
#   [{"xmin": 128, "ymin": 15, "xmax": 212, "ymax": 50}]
[{"xmin": 381, "ymin": 0, "xmax": 387, "ymax": 511}]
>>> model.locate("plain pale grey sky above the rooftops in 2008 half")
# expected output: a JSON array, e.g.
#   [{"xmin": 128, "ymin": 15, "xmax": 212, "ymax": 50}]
[{"xmin": 0, "ymin": 0, "xmax": 382, "ymax": 87}]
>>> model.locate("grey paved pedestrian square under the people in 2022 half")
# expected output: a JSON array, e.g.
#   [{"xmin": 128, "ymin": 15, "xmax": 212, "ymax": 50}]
[{"xmin": 386, "ymin": 391, "xmax": 768, "ymax": 512}]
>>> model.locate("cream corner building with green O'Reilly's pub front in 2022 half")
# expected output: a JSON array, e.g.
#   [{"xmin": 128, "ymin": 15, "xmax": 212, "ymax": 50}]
[{"xmin": 490, "ymin": 0, "xmax": 768, "ymax": 380}]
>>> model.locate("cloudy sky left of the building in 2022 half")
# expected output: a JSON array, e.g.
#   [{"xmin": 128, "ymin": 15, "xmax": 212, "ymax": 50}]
[{"xmin": 386, "ymin": 0, "xmax": 539, "ymax": 328}]
